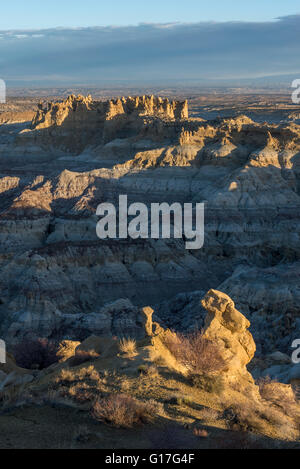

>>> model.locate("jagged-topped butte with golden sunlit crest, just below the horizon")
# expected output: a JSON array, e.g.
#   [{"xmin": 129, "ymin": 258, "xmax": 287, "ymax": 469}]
[{"xmin": 27, "ymin": 95, "xmax": 188, "ymax": 153}]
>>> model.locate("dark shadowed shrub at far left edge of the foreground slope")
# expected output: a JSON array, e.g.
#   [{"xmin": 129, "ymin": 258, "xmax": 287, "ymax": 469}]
[{"xmin": 13, "ymin": 338, "xmax": 58, "ymax": 370}]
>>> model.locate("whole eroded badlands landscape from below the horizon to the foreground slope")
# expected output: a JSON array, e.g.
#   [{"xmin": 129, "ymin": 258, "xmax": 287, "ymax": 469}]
[{"xmin": 0, "ymin": 90, "xmax": 300, "ymax": 449}]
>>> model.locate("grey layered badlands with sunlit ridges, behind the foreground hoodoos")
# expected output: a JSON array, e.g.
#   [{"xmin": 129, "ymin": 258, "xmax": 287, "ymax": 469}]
[{"xmin": 0, "ymin": 96, "xmax": 300, "ymax": 354}]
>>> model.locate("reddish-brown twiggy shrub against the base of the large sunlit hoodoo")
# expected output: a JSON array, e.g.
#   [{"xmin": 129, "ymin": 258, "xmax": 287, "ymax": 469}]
[{"xmin": 164, "ymin": 331, "xmax": 225, "ymax": 374}]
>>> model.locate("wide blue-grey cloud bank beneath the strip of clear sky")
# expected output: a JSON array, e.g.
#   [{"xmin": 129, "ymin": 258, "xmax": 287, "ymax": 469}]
[{"xmin": 0, "ymin": 15, "xmax": 300, "ymax": 85}]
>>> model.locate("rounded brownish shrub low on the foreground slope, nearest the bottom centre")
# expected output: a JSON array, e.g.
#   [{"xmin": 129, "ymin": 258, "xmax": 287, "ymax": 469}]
[{"xmin": 92, "ymin": 394, "xmax": 157, "ymax": 428}]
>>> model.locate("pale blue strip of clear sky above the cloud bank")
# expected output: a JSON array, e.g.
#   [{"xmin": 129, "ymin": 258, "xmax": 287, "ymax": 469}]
[{"xmin": 0, "ymin": 0, "xmax": 300, "ymax": 29}]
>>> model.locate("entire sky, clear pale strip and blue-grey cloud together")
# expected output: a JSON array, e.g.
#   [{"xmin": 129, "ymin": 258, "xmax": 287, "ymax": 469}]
[{"xmin": 0, "ymin": 0, "xmax": 300, "ymax": 87}]
